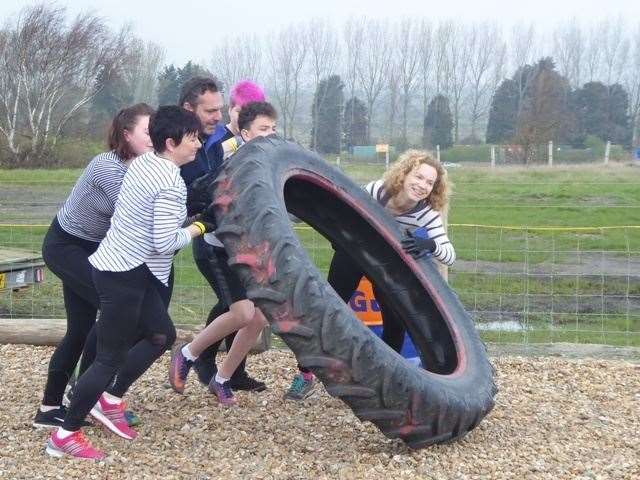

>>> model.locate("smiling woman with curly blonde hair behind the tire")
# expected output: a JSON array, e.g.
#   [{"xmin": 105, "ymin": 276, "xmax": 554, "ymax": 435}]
[{"xmin": 286, "ymin": 150, "xmax": 456, "ymax": 400}]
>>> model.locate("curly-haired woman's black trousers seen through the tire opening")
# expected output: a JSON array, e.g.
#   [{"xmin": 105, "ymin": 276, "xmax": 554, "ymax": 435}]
[{"xmin": 327, "ymin": 248, "xmax": 406, "ymax": 352}]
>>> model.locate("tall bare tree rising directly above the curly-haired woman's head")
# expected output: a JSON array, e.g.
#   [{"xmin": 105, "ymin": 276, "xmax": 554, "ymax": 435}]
[{"xmin": 389, "ymin": 18, "xmax": 422, "ymax": 145}]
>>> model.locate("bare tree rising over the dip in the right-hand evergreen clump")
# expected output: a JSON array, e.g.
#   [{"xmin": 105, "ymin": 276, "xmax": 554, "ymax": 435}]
[{"xmin": 553, "ymin": 18, "xmax": 585, "ymax": 88}]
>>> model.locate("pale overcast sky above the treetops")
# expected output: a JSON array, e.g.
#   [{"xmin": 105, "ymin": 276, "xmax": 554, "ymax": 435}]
[{"xmin": 0, "ymin": 0, "xmax": 640, "ymax": 65}]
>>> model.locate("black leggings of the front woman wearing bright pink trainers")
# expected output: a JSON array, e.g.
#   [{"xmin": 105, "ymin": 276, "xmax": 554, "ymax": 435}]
[{"xmin": 63, "ymin": 265, "xmax": 176, "ymax": 431}]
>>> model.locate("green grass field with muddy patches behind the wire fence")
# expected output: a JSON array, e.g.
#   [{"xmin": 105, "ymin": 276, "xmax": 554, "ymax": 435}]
[{"xmin": 0, "ymin": 164, "xmax": 640, "ymax": 345}]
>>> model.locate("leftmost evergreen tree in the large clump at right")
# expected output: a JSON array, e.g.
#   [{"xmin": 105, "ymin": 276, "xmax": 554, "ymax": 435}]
[{"xmin": 487, "ymin": 79, "xmax": 519, "ymax": 143}]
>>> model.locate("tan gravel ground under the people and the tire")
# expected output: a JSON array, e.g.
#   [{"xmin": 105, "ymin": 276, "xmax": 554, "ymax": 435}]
[{"xmin": 0, "ymin": 345, "xmax": 640, "ymax": 480}]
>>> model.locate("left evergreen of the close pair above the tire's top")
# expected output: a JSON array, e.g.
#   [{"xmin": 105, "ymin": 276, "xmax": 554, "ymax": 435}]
[{"xmin": 311, "ymin": 75, "xmax": 344, "ymax": 153}]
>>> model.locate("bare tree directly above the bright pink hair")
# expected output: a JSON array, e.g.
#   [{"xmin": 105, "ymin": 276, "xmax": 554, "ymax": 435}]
[{"xmin": 211, "ymin": 35, "xmax": 262, "ymax": 88}]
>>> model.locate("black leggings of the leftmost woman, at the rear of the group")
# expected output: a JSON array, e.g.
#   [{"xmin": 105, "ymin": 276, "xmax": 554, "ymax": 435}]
[{"xmin": 42, "ymin": 218, "xmax": 99, "ymax": 406}]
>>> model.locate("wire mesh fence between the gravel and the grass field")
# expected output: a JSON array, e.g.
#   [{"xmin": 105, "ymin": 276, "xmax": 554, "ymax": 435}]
[{"xmin": 0, "ymin": 224, "xmax": 640, "ymax": 346}]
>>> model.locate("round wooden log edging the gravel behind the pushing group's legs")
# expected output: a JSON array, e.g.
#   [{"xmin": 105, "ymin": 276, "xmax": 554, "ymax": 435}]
[{"xmin": 0, "ymin": 318, "xmax": 271, "ymax": 352}]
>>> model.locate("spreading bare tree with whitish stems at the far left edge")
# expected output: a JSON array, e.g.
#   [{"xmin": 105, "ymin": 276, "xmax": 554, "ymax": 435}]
[{"xmin": 0, "ymin": 5, "xmax": 129, "ymax": 164}]
